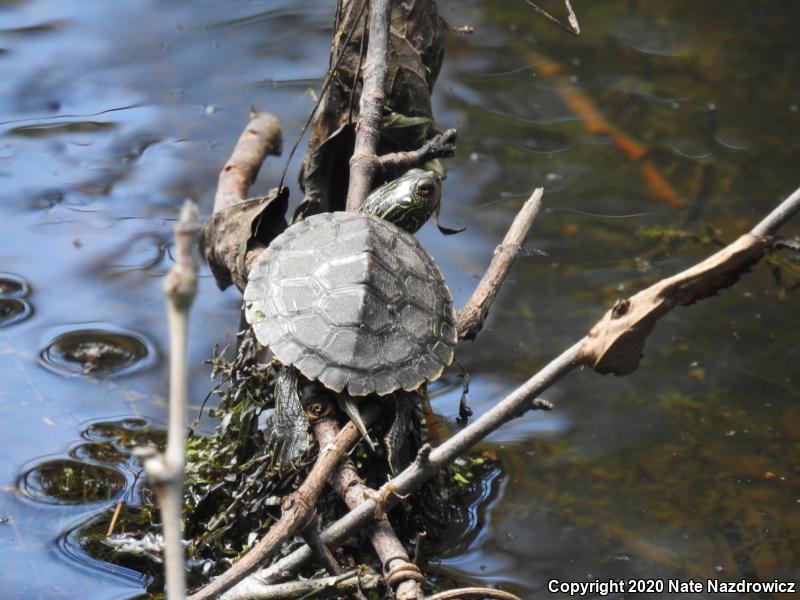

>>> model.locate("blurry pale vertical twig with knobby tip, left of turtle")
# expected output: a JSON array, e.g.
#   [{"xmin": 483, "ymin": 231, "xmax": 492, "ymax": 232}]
[{"xmin": 144, "ymin": 200, "xmax": 199, "ymax": 600}]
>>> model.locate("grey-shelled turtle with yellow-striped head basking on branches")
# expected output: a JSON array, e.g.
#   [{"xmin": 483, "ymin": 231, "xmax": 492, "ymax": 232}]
[{"xmin": 244, "ymin": 169, "xmax": 457, "ymax": 466}]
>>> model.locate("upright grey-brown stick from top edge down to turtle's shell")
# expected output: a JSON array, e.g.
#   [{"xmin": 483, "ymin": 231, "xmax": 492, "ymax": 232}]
[{"xmin": 347, "ymin": 0, "xmax": 391, "ymax": 212}]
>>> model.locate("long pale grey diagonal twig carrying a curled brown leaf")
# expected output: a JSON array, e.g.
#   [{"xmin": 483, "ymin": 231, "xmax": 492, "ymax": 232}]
[{"xmin": 230, "ymin": 185, "xmax": 800, "ymax": 579}]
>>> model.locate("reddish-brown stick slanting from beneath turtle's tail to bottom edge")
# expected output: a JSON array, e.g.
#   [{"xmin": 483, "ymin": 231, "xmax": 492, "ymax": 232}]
[{"xmin": 190, "ymin": 404, "xmax": 378, "ymax": 600}]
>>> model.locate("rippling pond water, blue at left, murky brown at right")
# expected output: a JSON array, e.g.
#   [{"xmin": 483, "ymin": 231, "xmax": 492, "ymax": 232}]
[{"xmin": 0, "ymin": 0, "xmax": 800, "ymax": 598}]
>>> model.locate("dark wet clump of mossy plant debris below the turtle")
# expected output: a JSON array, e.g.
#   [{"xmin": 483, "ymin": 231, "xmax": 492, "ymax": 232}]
[{"xmin": 185, "ymin": 333, "xmax": 493, "ymax": 575}]
